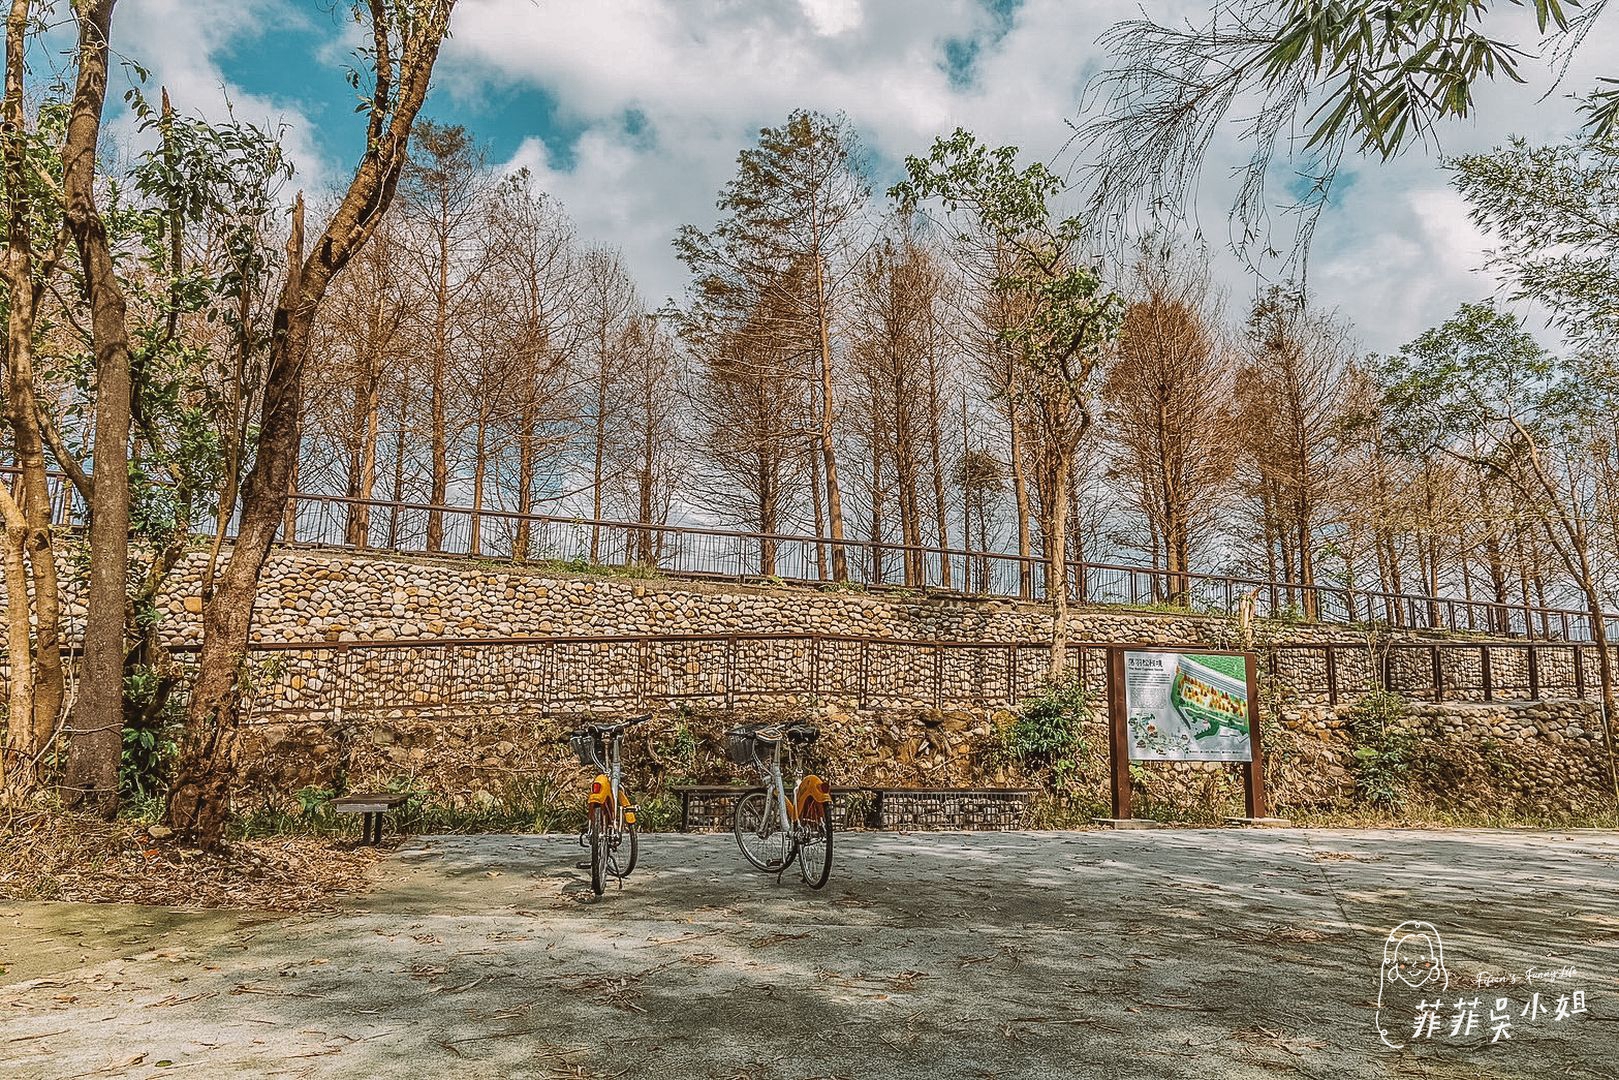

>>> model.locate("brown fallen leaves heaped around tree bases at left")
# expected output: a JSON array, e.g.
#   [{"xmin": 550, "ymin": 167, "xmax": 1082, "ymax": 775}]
[{"xmin": 0, "ymin": 811, "xmax": 380, "ymax": 912}]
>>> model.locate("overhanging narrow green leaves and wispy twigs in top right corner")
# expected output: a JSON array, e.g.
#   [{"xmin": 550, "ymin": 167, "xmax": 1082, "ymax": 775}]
[{"xmin": 1081, "ymin": 0, "xmax": 1619, "ymax": 268}]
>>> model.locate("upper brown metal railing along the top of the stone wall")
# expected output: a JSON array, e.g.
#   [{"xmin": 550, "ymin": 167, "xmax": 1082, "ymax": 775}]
[{"xmin": 9, "ymin": 466, "xmax": 1619, "ymax": 641}]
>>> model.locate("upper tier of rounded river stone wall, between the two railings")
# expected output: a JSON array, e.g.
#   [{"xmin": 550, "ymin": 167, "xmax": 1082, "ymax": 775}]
[{"xmin": 0, "ymin": 547, "xmax": 1470, "ymax": 644}]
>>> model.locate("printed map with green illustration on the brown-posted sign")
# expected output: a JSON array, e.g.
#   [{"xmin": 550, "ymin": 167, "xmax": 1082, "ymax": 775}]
[{"xmin": 1124, "ymin": 651, "xmax": 1253, "ymax": 761}]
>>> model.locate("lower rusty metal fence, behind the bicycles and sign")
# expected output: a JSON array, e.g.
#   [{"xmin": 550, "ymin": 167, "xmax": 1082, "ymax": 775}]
[{"xmin": 132, "ymin": 633, "xmax": 1600, "ymax": 722}]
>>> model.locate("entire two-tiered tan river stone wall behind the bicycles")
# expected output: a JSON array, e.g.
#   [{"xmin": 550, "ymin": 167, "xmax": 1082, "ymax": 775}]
[{"xmin": 6, "ymin": 549, "xmax": 1611, "ymax": 818}]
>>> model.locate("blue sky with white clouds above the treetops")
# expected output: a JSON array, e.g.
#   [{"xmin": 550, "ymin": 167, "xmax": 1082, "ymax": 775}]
[{"xmin": 94, "ymin": 0, "xmax": 1619, "ymax": 351}]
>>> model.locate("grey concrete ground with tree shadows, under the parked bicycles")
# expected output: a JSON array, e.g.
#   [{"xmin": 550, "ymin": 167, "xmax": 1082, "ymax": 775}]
[{"xmin": 0, "ymin": 831, "xmax": 1619, "ymax": 1080}]
